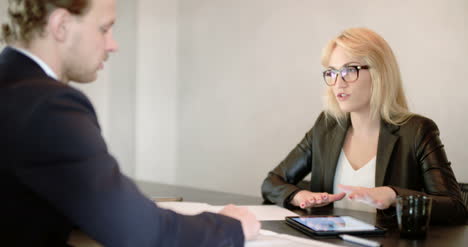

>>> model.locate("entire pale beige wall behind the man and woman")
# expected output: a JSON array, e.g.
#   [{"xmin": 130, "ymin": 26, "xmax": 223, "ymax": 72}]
[{"xmin": 0, "ymin": 0, "xmax": 468, "ymax": 195}]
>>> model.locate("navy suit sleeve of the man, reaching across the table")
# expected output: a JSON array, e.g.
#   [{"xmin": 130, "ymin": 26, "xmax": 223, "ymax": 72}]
[{"xmin": 15, "ymin": 89, "xmax": 244, "ymax": 247}]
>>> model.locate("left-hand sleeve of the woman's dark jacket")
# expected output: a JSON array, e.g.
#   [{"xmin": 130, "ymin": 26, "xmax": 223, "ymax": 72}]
[{"xmin": 262, "ymin": 113, "xmax": 324, "ymax": 207}]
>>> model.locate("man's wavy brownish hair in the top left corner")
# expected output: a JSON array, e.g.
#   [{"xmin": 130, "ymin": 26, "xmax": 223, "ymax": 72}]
[{"xmin": 0, "ymin": 0, "xmax": 91, "ymax": 44}]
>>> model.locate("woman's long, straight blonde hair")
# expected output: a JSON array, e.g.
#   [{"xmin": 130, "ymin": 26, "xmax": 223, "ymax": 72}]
[{"xmin": 322, "ymin": 28, "xmax": 412, "ymax": 125}]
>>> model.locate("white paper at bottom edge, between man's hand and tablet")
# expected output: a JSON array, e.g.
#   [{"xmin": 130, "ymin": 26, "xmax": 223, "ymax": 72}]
[{"xmin": 245, "ymin": 230, "xmax": 340, "ymax": 247}]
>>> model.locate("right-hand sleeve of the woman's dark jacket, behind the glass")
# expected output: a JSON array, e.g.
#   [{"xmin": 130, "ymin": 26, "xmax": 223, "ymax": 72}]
[{"xmin": 390, "ymin": 119, "xmax": 467, "ymax": 223}]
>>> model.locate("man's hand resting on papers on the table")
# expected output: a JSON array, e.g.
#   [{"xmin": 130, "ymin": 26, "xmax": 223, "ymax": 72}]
[{"xmin": 219, "ymin": 205, "xmax": 260, "ymax": 240}]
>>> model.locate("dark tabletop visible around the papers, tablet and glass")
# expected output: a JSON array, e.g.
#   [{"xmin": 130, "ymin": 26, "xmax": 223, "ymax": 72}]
[{"xmin": 70, "ymin": 181, "xmax": 468, "ymax": 247}]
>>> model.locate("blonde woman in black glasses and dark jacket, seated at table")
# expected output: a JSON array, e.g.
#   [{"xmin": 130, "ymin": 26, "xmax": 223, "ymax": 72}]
[{"xmin": 262, "ymin": 28, "xmax": 466, "ymax": 222}]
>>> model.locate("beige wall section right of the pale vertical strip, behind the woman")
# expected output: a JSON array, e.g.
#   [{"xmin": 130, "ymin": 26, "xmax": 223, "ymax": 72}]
[{"xmin": 177, "ymin": 0, "xmax": 468, "ymax": 195}]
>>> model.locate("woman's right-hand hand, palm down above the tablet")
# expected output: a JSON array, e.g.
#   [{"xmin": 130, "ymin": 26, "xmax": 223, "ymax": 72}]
[{"xmin": 338, "ymin": 184, "xmax": 396, "ymax": 209}]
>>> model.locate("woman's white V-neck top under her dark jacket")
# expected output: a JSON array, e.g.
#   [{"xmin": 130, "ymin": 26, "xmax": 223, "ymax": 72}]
[{"xmin": 333, "ymin": 149, "xmax": 376, "ymax": 213}]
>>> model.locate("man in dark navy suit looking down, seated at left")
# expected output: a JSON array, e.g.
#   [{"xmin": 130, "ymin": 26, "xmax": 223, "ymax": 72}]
[{"xmin": 0, "ymin": 0, "xmax": 260, "ymax": 247}]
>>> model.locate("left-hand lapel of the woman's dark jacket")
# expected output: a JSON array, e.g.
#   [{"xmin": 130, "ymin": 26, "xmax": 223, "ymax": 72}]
[{"xmin": 323, "ymin": 121, "xmax": 350, "ymax": 193}]
